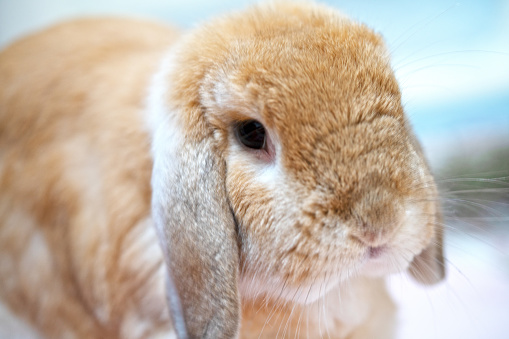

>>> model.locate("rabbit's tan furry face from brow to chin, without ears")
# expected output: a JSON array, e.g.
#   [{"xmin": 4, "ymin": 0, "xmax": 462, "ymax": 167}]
[{"xmin": 192, "ymin": 24, "xmax": 437, "ymax": 302}]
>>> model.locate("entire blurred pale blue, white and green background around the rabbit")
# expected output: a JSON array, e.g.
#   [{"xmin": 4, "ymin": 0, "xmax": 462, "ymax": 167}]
[{"xmin": 0, "ymin": 0, "xmax": 509, "ymax": 339}]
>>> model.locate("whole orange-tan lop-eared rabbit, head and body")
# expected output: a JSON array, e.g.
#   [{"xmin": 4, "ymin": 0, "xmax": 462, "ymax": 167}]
[{"xmin": 0, "ymin": 1, "xmax": 445, "ymax": 339}]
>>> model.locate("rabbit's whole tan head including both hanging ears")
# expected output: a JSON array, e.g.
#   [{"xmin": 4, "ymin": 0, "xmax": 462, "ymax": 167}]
[{"xmin": 148, "ymin": 3, "xmax": 444, "ymax": 338}]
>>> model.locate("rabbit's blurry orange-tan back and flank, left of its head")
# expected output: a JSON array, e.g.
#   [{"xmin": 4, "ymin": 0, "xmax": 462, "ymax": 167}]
[{"xmin": 0, "ymin": 19, "xmax": 176, "ymax": 338}]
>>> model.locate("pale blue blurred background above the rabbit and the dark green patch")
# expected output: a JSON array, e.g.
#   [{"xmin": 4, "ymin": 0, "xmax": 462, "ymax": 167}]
[{"xmin": 0, "ymin": 0, "xmax": 509, "ymax": 165}]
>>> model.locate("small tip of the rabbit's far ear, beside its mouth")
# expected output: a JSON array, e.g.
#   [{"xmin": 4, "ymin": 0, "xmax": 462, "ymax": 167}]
[{"xmin": 408, "ymin": 212, "xmax": 445, "ymax": 285}]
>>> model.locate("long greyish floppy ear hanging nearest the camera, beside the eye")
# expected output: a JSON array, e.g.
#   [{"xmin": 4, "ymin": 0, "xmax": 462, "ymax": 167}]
[{"xmin": 152, "ymin": 111, "xmax": 240, "ymax": 338}]
